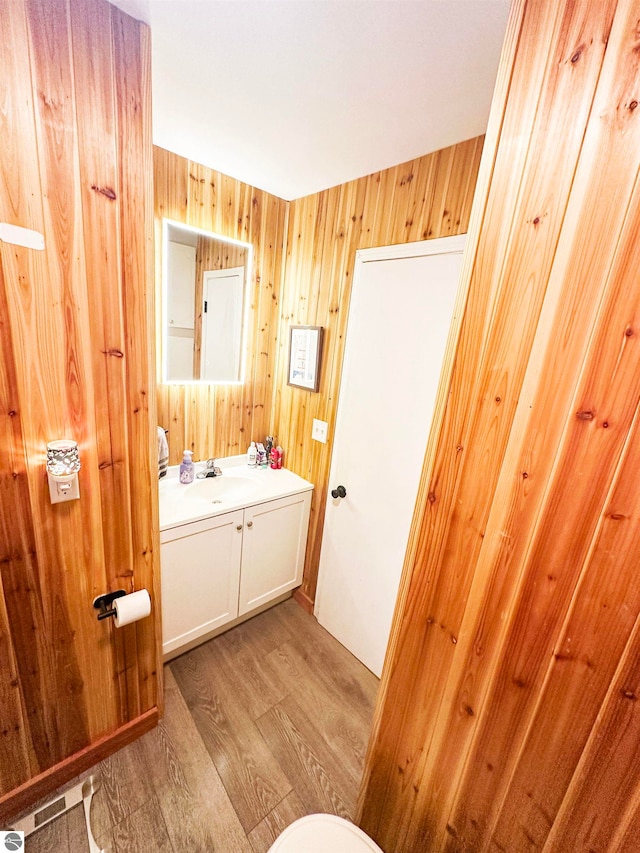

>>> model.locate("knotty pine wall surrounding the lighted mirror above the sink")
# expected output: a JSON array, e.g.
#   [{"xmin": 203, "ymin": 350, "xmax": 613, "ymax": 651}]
[{"xmin": 153, "ymin": 147, "xmax": 288, "ymax": 465}]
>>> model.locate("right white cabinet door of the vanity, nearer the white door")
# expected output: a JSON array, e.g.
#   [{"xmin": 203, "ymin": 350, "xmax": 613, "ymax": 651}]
[{"xmin": 238, "ymin": 492, "xmax": 311, "ymax": 616}]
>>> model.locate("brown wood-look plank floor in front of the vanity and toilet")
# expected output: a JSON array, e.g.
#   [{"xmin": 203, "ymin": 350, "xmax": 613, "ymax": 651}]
[{"xmin": 16, "ymin": 599, "xmax": 378, "ymax": 853}]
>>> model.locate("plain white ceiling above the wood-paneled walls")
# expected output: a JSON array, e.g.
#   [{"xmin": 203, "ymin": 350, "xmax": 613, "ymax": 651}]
[{"xmin": 113, "ymin": 0, "xmax": 509, "ymax": 199}]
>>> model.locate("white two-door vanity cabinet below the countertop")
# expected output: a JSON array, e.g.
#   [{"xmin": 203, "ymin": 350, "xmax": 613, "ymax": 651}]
[{"xmin": 160, "ymin": 490, "xmax": 311, "ymax": 659}]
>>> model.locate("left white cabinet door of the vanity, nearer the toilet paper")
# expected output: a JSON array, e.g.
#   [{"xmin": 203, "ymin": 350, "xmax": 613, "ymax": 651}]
[{"xmin": 161, "ymin": 510, "xmax": 242, "ymax": 654}]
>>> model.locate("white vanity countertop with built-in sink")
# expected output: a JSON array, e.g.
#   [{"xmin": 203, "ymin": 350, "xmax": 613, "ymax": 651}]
[{"xmin": 158, "ymin": 456, "xmax": 313, "ymax": 530}]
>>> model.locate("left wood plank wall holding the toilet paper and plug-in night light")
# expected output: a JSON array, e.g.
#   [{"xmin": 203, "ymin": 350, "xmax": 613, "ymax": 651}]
[{"xmin": 0, "ymin": 0, "xmax": 161, "ymax": 823}]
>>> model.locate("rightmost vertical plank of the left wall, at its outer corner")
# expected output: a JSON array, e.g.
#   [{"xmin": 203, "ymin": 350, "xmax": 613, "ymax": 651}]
[{"xmin": 112, "ymin": 9, "xmax": 163, "ymax": 718}]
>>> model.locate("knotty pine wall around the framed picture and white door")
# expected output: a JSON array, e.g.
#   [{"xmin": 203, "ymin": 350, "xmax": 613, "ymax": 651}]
[{"xmin": 272, "ymin": 137, "xmax": 483, "ymax": 608}]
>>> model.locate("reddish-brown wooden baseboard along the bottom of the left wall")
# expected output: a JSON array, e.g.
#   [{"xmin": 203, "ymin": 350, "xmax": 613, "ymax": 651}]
[{"xmin": 0, "ymin": 708, "xmax": 160, "ymax": 828}]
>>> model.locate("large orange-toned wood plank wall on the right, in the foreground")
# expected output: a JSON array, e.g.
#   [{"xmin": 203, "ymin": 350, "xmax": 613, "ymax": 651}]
[{"xmin": 359, "ymin": 0, "xmax": 640, "ymax": 853}]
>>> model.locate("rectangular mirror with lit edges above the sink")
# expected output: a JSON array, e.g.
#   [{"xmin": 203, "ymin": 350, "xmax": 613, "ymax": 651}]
[{"xmin": 162, "ymin": 219, "xmax": 252, "ymax": 385}]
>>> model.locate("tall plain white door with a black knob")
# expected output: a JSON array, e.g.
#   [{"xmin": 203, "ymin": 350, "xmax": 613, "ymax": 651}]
[{"xmin": 315, "ymin": 236, "xmax": 465, "ymax": 676}]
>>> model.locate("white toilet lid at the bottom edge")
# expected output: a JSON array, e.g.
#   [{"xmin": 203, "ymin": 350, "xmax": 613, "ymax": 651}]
[{"xmin": 269, "ymin": 814, "xmax": 383, "ymax": 853}]
